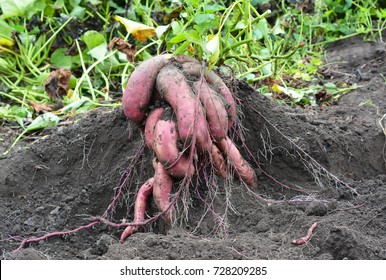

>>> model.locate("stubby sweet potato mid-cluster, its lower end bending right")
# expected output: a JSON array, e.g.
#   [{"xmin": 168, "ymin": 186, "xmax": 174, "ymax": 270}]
[{"xmin": 153, "ymin": 119, "xmax": 194, "ymax": 178}]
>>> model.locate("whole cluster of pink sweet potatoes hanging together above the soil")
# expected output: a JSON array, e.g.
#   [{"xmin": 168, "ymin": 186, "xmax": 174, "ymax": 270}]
[{"xmin": 121, "ymin": 54, "xmax": 257, "ymax": 242}]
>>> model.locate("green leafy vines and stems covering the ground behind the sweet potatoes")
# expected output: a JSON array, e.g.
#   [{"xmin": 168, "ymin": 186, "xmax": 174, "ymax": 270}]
[{"xmin": 0, "ymin": 0, "xmax": 386, "ymax": 153}]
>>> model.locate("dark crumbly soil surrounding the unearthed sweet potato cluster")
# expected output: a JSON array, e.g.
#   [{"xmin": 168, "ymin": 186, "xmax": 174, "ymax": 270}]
[{"xmin": 0, "ymin": 37, "xmax": 386, "ymax": 259}]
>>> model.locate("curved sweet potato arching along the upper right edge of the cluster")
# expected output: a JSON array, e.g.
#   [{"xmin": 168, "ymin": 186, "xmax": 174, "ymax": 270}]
[{"xmin": 181, "ymin": 62, "xmax": 237, "ymax": 128}]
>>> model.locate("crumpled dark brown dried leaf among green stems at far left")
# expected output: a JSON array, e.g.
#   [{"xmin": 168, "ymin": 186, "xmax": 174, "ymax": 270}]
[{"xmin": 45, "ymin": 68, "xmax": 71, "ymax": 100}]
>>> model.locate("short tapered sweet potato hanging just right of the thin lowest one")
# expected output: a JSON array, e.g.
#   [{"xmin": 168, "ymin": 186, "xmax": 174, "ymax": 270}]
[{"xmin": 153, "ymin": 159, "xmax": 173, "ymax": 226}]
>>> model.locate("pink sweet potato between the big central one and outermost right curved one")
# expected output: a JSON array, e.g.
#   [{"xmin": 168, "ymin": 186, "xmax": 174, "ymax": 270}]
[{"xmin": 193, "ymin": 80, "xmax": 228, "ymax": 142}]
